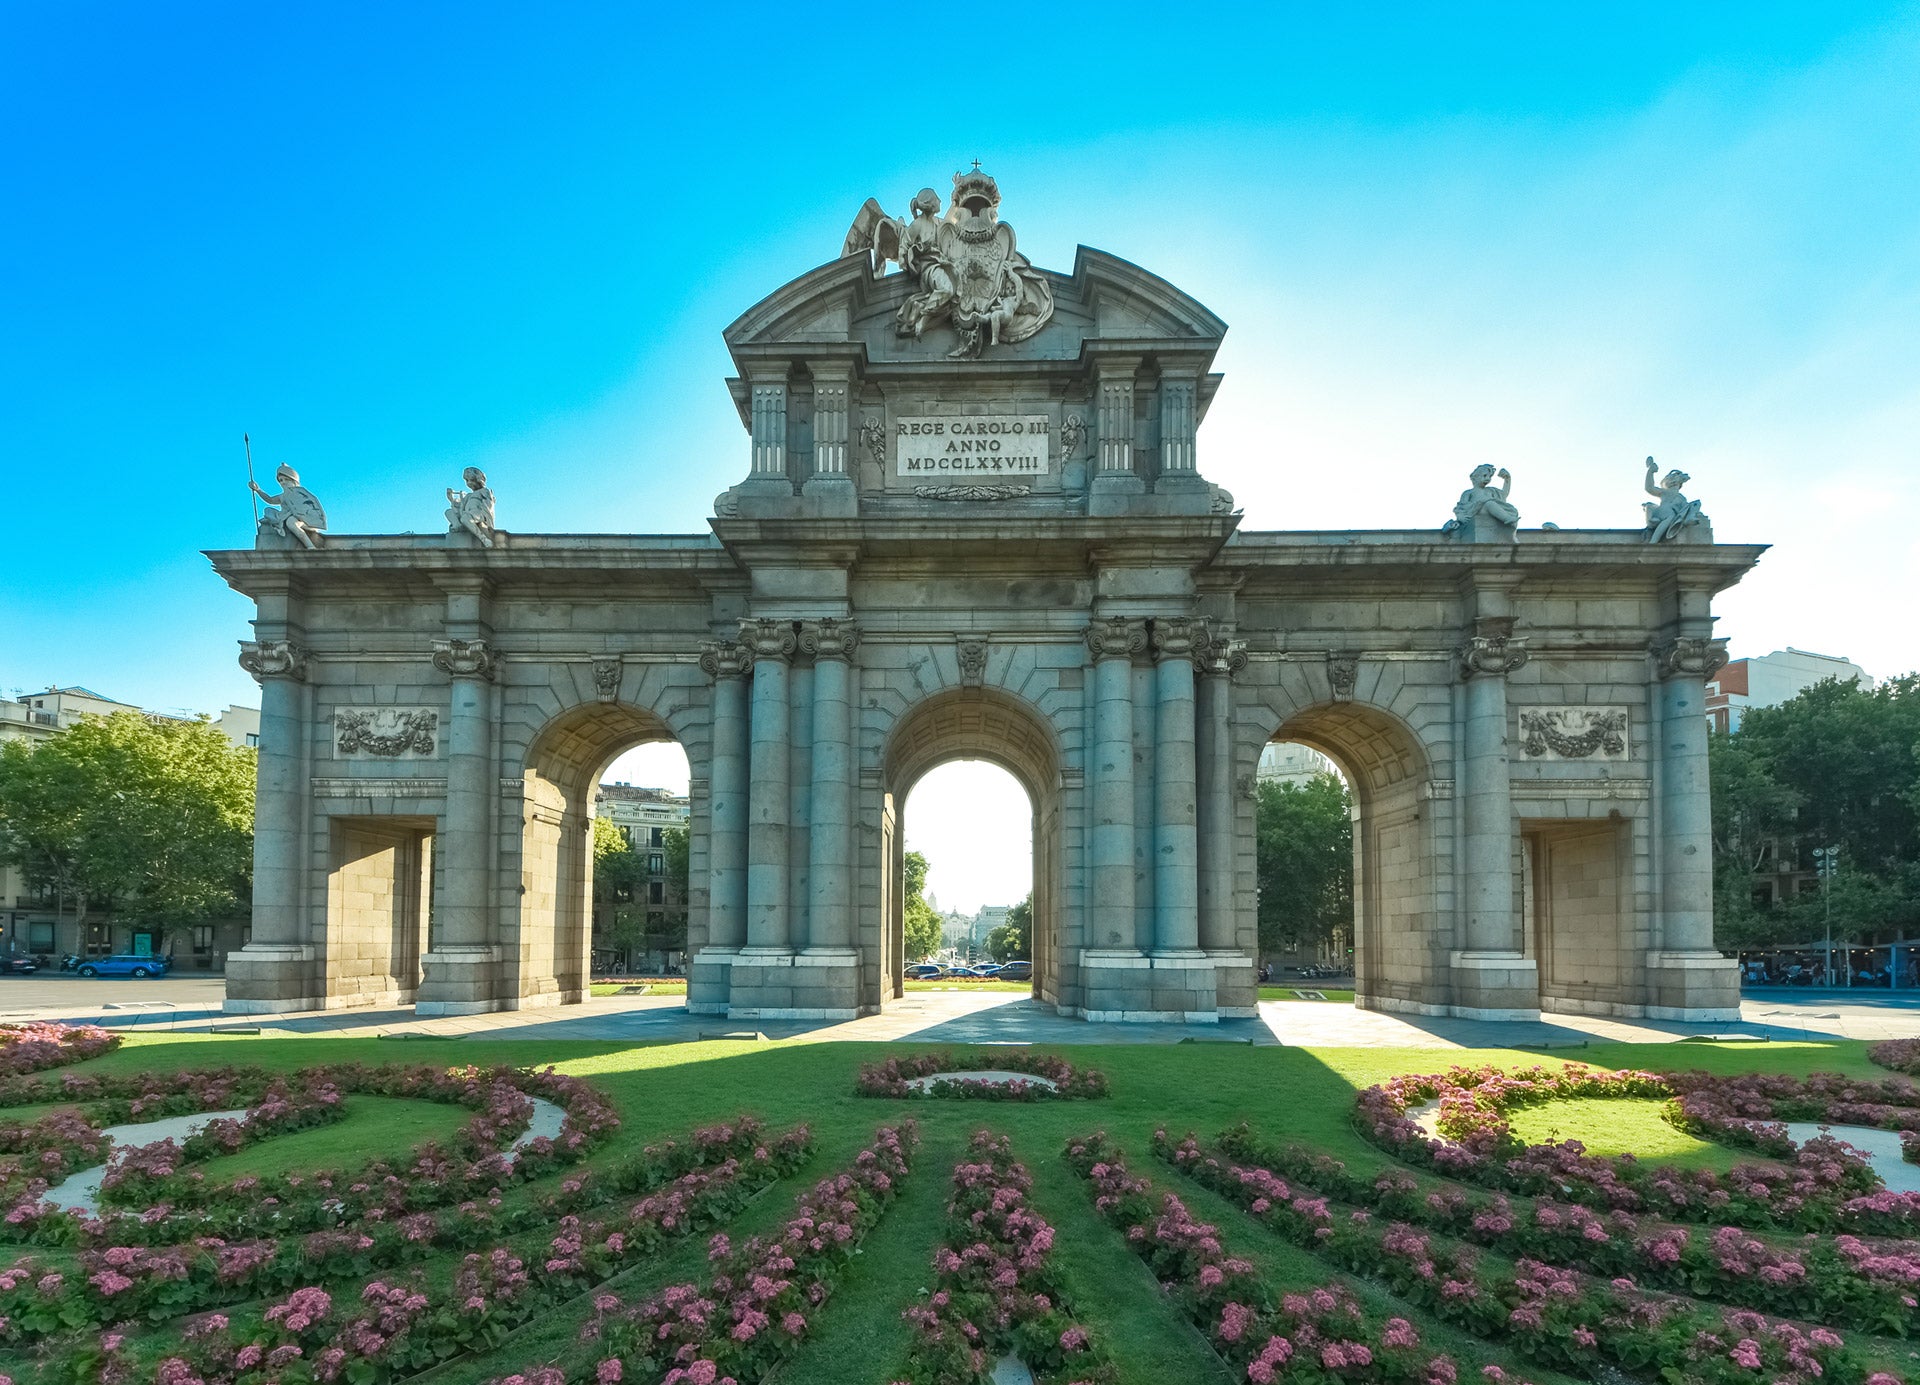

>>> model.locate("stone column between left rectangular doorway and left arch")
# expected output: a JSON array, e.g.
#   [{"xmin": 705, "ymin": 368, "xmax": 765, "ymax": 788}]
[{"xmin": 415, "ymin": 638, "xmax": 499, "ymax": 1014}]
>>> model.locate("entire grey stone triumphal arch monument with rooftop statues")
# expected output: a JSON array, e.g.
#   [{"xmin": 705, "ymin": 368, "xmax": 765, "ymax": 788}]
[{"xmin": 211, "ymin": 173, "xmax": 1761, "ymax": 1020}]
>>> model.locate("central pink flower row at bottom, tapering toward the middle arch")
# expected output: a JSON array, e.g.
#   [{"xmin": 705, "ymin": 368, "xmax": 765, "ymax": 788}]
[{"xmin": 895, "ymin": 1130, "xmax": 1114, "ymax": 1385}]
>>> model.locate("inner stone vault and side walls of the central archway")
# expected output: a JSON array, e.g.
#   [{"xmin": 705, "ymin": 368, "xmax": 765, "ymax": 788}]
[{"xmin": 879, "ymin": 688, "xmax": 1062, "ymax": 1005}]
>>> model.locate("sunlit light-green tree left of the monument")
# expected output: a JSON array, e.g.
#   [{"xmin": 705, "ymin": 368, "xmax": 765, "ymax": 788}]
[{"xmin": 0, "ymin": 713, "xmax": 255, "ymax": 945}]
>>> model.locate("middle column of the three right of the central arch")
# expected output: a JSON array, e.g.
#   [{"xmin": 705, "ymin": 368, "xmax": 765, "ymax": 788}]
[{"xmin": 1154, "ymin": 617, "xmax": 1200, "ymax": 953}]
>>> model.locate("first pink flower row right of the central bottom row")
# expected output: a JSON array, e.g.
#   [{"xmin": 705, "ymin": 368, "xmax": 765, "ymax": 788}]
[{"xmin": 1066, "ymin": 1133, "xmax": 1474, "ymax": 1385}]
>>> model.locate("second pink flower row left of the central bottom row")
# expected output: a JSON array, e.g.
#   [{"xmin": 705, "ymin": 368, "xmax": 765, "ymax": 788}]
[{"xmin": 139, "ymin": 1122, "xmax": 812, "ymax": 1385}]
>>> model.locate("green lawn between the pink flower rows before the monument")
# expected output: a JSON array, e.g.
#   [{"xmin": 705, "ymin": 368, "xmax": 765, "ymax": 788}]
[{"xmin": 0, "ymin": 1029, "xmax": 1878, "ymax": 1385}]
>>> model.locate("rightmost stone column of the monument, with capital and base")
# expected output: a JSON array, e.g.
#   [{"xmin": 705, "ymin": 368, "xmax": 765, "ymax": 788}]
[{"xmin": 1647, "ymin": 636, "xmax": 1740, "ymax": 1020}]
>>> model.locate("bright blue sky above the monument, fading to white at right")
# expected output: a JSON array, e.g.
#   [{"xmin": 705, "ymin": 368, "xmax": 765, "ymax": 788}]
[{"xmin": 0, "ymin": 4, "xmax": 1920, "ymax": 745}]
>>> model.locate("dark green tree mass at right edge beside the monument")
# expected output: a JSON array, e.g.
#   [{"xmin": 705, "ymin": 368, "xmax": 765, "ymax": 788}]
[{"xmin": 1709, "ymin": 674, "xmax": 1920, "ymax": 947}]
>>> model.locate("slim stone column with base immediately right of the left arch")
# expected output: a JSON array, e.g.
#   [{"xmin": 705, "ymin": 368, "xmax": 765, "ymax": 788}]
[{"xmin": 687, "ymin": 640, "xmax": 753, "ymax": 1014}]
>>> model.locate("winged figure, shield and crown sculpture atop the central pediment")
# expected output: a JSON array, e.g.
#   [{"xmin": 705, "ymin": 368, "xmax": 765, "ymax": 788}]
[{"xmin": 841, "ymin": 159, "xmax": 1054, "ymax": 361}]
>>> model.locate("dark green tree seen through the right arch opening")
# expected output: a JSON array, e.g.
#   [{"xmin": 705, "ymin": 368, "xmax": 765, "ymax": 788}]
[{"xmin": 1256, "ymin": 774, "xmax": 1354, "ymax": 953}]
